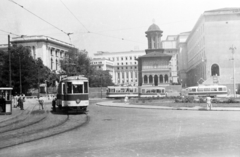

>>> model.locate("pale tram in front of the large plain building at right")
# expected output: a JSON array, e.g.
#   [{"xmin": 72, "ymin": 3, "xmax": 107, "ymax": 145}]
[{"xmin": 185, "ymin": 85, "xmax": 228, "ymax": 97}]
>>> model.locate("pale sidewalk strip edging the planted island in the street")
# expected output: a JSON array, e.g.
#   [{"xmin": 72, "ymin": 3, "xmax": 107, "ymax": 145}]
[{"xmin": 97, "ymin": 101, "xmax": 240, "ymax": 111}]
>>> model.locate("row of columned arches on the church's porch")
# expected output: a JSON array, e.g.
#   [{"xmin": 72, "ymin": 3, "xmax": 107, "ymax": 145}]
[{"xmin": 142, "ymin": 74, "xmax": 169, "ymax": 84}]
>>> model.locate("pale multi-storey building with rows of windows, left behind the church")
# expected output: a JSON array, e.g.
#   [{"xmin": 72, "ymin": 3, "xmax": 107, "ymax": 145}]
[{"xmin": 92, "ymin": 50, "xmax": 145, "ymax": 86}]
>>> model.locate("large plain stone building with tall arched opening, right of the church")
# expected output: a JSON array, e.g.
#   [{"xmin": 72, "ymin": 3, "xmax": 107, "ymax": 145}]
[{"xmin": 178, "ymin": 8, "xmax": 240, "ymax": 94}]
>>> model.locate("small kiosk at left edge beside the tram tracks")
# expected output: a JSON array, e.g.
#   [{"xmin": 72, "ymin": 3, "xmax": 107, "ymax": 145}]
[{"xmin": 0, "ymin": 87, "xmax": 13, "ymax": 114}]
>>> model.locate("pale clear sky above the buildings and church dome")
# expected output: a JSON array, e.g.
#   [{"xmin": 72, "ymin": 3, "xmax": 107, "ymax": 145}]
[{"xmin": 0, "ymin": 0, "xmax": 240, "ymax": 57}]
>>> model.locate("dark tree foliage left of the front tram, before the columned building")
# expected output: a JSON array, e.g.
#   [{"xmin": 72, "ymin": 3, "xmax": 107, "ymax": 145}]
[{"xmin": 0, "ymin": 46, "xmax": 58, "ymax": 94}]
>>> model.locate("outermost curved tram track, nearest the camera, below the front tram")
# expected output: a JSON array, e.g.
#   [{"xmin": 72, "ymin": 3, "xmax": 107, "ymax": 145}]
[{"xmin": 0, "ymin": 114, "xmax": 90, "ymax": 149}]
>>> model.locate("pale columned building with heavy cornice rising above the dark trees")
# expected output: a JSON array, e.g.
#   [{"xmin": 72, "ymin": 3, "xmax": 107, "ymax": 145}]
[{"xmin": 11, "ymin": 35, "xmax": 76, "ymax": 72}]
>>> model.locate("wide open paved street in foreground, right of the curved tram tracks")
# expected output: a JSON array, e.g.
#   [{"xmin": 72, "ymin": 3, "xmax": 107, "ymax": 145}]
[{"xmin": 0, "ymin": 100, "xmax": 240, "ymax": 157}]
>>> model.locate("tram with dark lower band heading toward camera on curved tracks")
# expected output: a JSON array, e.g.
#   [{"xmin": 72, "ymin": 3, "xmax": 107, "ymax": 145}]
[{"xmin": 56, "ymin": 75, "xmax": 89, "ymax": 111}]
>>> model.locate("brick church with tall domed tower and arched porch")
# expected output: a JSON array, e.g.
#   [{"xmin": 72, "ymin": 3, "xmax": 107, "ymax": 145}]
[{"xmin": 138, "ymin": 23, "xmax": 172, "ymax": 87}]
